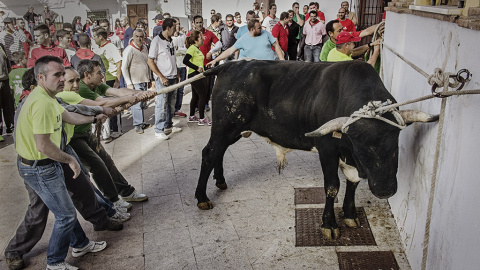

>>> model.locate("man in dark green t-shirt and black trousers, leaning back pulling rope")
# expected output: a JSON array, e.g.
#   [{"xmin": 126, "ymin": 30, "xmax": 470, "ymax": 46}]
[{"xmin": 66, "ymin": 60, "xmax": 151, "ymax": 209}]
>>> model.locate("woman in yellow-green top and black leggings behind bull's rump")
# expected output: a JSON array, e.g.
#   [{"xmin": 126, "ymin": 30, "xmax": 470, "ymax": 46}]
[{"xmin": 183, "ymin": 30, "xmax": 212, "ymax": 126}]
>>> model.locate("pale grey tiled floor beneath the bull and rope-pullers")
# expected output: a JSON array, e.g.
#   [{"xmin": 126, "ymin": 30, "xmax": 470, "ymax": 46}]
[{"xmin": 0, "ymin": 91, "xmax": 410, "ymax": 270}]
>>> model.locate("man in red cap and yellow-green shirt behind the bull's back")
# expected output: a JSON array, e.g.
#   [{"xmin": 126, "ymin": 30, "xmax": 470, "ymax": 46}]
[{"xmin": 327, "ymin": 32, "xmax": 380, "ymax": 66}]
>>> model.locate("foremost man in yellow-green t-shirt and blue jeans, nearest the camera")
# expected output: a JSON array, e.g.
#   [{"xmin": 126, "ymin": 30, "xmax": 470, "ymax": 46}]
[{"xmin": 15, "ymin": 56, "xmax": 106, "ymax": 269}]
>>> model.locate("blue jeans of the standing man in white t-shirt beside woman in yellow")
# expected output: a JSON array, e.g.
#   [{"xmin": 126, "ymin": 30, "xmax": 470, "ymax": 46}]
[{"xmin": 155, "ymin": 77, "xmax": 178, "ymax": 133}]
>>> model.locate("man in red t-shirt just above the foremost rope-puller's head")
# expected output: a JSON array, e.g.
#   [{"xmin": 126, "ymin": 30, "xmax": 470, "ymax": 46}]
[{"xmin": 27, "ymin": 24, "xmax": 71, "ymax": 68}]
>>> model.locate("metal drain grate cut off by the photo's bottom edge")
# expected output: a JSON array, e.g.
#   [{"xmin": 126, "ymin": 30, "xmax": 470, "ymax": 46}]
[{"xmin": 337, "ymin": 251, "xmax": 400, "ymax": 270}]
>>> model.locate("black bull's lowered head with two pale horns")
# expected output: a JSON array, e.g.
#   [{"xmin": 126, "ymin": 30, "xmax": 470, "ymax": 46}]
[{"xmin": 305, "ymin": 110, "xmax": 438, "ymax": 198}]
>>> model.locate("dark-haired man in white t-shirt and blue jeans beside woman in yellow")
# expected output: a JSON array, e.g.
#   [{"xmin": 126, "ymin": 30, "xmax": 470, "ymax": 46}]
[{"xmin": 147, "ymin": 18, "xmax": 182, "ymax": 140}]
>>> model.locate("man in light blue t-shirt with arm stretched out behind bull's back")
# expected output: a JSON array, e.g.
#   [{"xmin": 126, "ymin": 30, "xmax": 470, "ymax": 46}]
[{"xmin": 207, "ymin": 19, "xmax": 285, "ymax": 67}]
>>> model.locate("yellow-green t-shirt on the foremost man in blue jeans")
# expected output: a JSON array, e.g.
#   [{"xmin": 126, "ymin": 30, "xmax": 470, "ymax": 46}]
[{"xmin": 15, "ymin": 86, "xmax": 65, "ymax": 160}]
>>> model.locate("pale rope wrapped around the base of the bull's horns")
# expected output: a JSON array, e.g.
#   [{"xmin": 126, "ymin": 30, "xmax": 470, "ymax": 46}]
[{"xmin": 341, "ymin": 99, "xmax": 407, "ymax": 134}]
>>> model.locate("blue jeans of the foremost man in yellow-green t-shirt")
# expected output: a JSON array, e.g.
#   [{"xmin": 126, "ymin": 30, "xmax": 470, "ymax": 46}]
[{"xmin": 17, "ymin": 160, "xmax": 89, "ymax": 264}]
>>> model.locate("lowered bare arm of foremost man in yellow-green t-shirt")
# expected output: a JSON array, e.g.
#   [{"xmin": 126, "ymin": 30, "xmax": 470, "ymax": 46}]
[{"xmin": 34, "ymin": 134, "xmax": 81, "ymax": 178}]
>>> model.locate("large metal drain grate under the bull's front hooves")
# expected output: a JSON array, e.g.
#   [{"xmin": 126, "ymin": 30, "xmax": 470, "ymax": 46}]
[{"xmin": 295, "ymin": 207, "xmax": 377, "ymax": 247}]
